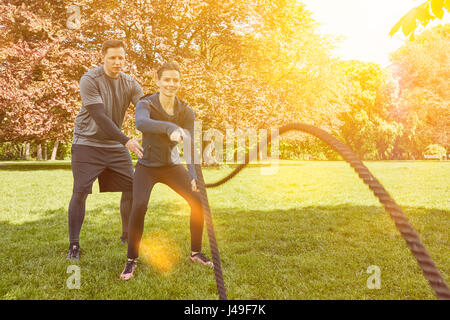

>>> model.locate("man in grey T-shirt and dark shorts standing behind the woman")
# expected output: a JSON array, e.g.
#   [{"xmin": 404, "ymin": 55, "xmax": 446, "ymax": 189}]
[{"xmin": 67, "ymin": 40, "xmax": 144, "ymax": 260}]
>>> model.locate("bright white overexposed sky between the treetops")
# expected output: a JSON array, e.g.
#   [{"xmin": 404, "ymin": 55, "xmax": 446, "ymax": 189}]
[{"xmin": 299, "ymin": 0, "xmax": 450, "ymax": 66}]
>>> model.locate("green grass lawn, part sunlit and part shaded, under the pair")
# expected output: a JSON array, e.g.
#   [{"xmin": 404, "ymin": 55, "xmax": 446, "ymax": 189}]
[{"xmin": 0, "ymin": 161, "xmax": 450, "ymax": 300}]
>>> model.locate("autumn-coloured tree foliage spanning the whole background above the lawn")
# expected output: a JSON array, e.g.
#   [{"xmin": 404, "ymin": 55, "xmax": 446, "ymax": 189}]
[{"xmin": 0, "ymin": 0, "xmax": 450, "ymax": 159}]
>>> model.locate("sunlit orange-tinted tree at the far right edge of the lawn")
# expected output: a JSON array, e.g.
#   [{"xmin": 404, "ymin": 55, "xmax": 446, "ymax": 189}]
[{"xmin": 391, "ymin": 24, "xmax": 450, "ymax": 158}]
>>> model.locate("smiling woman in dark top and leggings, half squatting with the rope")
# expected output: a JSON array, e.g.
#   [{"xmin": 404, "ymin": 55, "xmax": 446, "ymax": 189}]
[{"xmin": 120, "ymin": 62, "xmax": 213, "ymax": 280}]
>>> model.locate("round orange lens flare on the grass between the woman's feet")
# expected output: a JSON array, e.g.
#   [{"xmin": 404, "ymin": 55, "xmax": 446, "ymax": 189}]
[{"xmin": 139, "ymin": 232, "xmax": 180, "ymax": 274}]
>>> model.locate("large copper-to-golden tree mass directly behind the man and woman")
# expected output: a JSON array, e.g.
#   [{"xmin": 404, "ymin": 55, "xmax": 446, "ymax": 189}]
[{"xmin": 0, "ymin": 0, "xmax": 343, "ymax": 160}]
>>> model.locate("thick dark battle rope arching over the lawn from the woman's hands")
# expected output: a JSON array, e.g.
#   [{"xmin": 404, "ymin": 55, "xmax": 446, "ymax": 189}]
[{"xmin": 196, "ymin": 123, "xmax": 450, "ymax": 300}]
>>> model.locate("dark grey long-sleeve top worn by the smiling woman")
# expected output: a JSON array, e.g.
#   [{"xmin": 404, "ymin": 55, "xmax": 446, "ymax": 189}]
[{"xmin": 135, "ymin": 92, "xmax": 197, "ymax": 179}]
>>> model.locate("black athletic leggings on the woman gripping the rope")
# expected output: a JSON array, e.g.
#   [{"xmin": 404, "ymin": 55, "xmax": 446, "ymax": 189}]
[{"xmin": 128, "ymin": 163, "xmax": 204, "ymax": 259}]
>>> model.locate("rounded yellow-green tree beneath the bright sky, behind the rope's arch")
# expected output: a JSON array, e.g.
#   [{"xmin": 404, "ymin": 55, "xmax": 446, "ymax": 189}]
[{"xmin": 340, "ymin": 61, "xmax": 402, "ymax": 160}]
